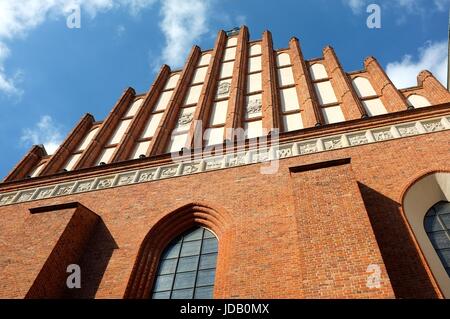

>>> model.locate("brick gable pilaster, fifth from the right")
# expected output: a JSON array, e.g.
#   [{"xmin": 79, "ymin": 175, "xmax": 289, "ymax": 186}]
[{"xmin": 262, "ymin": 30, "xmax": 280, "ymax": 131}]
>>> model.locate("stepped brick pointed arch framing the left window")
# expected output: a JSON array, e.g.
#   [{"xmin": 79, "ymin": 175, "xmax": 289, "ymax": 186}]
[{"xmin": 124, "ymin": 203, "xmax": 233, "ymax": 299}]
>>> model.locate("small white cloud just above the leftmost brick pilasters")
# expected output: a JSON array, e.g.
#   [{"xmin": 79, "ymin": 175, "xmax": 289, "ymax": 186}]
[{"xmin": 20, "ymin": 115, "xmax": 63, "ymax": 154}]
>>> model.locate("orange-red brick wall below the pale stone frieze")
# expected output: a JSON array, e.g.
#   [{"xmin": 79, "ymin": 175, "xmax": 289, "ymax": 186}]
[{"xmin": 0, "ymin": 131, "xmax": 450, "ymax": 298}]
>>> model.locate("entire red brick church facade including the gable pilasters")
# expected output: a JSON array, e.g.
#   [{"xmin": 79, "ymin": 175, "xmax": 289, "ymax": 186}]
[{"xmin": 0, "ymin": 27, "xmax": 450, "ymax": 298}]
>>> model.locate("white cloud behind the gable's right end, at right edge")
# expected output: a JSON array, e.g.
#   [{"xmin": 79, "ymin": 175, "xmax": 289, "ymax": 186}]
[{"xmin": 386, "ymin": 41, "xmax": 447, "ymax": 88}]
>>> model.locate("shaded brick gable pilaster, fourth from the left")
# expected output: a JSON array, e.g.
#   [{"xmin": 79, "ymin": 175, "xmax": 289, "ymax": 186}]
[{"xmin": 113, "ymin": 65, "xmax": 170, "ymax": 162}]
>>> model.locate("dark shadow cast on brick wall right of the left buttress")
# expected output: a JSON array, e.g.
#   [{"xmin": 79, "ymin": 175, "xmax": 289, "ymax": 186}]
[{"xmin": 65, "ymin": 220, "xmax": 118, "ymax": 299}]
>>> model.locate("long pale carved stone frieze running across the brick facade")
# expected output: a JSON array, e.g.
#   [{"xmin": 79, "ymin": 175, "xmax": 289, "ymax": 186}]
[{"xmin": 0, "ymin": 117, "xmax": 450, "ymax": 206}]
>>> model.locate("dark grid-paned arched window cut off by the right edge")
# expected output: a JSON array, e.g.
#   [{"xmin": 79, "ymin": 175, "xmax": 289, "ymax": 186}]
[{"xmin": 424, "ymin": 201, "xmax": 450, "ymax": 276}]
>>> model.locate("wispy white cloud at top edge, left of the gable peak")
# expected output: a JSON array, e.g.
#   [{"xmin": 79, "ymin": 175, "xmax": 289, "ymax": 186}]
[{"xmin": 160, "ymin": 0, "xmax": 210, "ymax": 67}]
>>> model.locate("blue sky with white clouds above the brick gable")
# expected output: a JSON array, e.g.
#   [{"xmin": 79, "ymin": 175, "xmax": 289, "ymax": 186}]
[{"xmin": 0, "ymin": 0, "xmax": 450, "ymax": 178}]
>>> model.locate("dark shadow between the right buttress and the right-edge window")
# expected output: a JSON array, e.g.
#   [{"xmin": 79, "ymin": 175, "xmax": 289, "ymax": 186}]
[{"xmin": 358, "ymin": 183, "xmax": 438, "ymax": 298}]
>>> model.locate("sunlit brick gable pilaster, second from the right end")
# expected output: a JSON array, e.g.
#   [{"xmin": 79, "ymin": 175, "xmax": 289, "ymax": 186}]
[{"xmin": 364, "ymin": 56, "xmax": 408, "ymax": 113}]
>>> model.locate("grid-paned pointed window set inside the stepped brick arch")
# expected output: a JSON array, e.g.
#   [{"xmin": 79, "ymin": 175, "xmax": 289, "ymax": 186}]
[{"xmin": 152, "ymin": 227, "xmax": 218, "ymax": 299}]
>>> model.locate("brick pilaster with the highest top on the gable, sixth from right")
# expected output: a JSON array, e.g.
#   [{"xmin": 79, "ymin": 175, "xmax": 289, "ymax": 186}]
[{"xmin": 225, "ymin": 26, "xmax": 249, "ymax": 140}]
